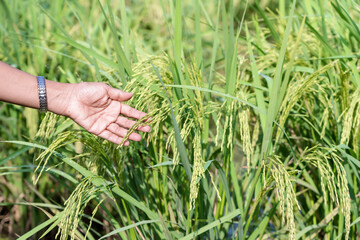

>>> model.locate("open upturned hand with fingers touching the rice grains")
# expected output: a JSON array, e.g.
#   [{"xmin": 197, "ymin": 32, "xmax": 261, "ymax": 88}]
[{"xmin": 60, "ymin": 83, "xmax": 150, "ymax": 146}]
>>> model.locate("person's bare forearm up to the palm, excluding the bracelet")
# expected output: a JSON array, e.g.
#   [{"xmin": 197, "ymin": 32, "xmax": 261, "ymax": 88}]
[{"xmin": 0, "ymin": 61, "xmax": 71, "ymax": 115}]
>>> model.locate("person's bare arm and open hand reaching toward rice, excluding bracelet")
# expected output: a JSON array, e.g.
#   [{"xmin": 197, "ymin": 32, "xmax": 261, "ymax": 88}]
[{"xmin": 0, "ymin": 61, "xmax": 150, "ymax": 145}]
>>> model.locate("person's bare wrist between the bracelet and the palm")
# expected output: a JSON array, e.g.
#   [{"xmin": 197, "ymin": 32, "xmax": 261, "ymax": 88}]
[{"xmin": 46, "ymin": 80, "xmax": 74, "ymax": 117}]
